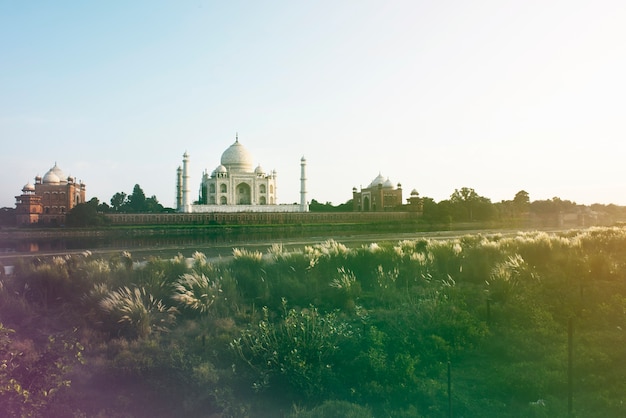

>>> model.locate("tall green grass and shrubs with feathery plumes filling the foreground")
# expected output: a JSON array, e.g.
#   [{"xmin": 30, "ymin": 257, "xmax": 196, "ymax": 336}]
[{"xmin": 0, "ymin": 227, "xmax": 626, "ymax": 418}]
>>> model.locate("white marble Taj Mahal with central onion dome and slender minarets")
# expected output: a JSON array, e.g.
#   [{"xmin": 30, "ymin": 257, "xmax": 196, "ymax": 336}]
[{"xmin": 176, "ymin": 135, "xmax": 309, "ymax": 213}]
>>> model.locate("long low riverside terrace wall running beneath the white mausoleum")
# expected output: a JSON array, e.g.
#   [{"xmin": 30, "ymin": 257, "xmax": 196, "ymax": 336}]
[{"xmin": 105, "ymin": 212, "xmax": 418, "ymax": 225}]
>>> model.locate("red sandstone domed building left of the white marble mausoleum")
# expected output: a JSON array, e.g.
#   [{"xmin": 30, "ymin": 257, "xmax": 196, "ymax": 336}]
[{"xmin": 15, "ymin": 163, "xmax": 86, "ymax": 225}]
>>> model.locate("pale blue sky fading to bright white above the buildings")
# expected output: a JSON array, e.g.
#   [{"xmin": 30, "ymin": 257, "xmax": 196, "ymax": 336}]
[{"xmin": 0, "ymin": 0, "xmax": 626, "ymax": 207}]
